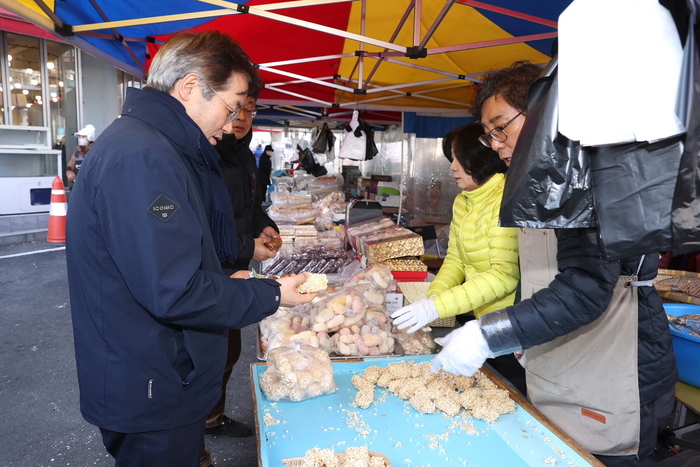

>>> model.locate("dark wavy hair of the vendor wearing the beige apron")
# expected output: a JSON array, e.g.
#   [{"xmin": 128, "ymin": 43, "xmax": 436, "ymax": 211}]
[{"xmin": 471, "ymin": 61, "xmax": 542, "ymax": 121}]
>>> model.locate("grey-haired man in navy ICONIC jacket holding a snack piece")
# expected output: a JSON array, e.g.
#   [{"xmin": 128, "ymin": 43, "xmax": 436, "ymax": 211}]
[{"xmin": 66, "ymin": 32, "xmax": 316, "ymax": 467}]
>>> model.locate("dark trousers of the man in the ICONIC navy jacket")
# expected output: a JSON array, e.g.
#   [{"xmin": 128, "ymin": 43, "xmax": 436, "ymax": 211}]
[{"xmin": 100, "ymin": 417, "xmax": 206, "ymax": 467}]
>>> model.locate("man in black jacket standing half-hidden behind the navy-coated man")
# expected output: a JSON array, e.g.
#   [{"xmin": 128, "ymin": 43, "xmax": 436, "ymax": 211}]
[{"xmin": 200, "ymin": 88, "xmax": 279, "ymax": 454}]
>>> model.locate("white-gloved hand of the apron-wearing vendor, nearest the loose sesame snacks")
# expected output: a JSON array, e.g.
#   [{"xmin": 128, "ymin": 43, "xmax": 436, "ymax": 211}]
[{"xmin": 430, "ymin": 320, "xmax": 495, "ymax": 376}]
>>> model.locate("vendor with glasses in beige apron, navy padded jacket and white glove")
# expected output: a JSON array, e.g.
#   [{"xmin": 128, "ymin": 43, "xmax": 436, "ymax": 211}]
[{"xmin": 433, "ymin": 63, "xmax": 677, "ymax": 466}]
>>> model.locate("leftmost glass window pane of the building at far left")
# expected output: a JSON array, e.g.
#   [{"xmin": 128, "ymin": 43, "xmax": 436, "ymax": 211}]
[{"xmin": 7, "ymin": 34, "xmax": 44, "ymax": 126}]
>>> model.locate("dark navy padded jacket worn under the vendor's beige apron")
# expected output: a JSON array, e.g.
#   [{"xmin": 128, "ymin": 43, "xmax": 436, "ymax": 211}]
[{"xmin": 506, "ymin": 229, "xmax": 677, "ymax": 405}]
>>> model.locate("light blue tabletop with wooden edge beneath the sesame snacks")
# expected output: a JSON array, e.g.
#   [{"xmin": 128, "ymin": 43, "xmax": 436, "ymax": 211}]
[{"xmin": 251, "ymin": 355, "xmax": 602, "ymax": 467}]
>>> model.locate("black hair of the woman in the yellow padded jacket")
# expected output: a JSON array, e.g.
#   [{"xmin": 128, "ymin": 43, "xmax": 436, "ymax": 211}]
[{"xmin": 452, "ymin": 122, "xmax": 508, "ymax": 185}]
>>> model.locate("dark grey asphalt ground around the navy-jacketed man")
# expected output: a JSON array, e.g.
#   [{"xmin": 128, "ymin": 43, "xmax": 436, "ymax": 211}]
[{"xmin": 0, "ymin": 242, "xmax": 258, "ymax": 467}]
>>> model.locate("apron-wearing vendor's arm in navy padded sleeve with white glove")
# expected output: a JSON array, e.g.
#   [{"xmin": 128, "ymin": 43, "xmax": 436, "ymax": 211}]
[{"xmin": 431, "ymin": 229, "xmax": 620, "ymax": 376}]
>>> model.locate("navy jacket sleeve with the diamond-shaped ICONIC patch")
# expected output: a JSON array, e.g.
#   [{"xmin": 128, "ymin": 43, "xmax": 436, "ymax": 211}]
[{"xmin": 94, "ymin": 148, "xmax": 304, "ymax": 329}]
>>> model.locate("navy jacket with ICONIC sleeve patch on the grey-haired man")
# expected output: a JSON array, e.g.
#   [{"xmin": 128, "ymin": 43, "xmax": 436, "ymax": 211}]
[{"xmin": 66, "ymin": 88, "xmax": 280, "ymax": 433}]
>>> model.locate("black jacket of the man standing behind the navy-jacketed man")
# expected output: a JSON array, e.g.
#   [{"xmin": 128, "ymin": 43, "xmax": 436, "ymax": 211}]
[{"xmin": 216, "ymin": 131, "xmax": 279, "ymax": 270}]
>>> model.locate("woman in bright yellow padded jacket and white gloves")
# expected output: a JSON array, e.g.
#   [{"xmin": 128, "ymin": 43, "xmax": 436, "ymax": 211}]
[{"xmin": 391, "ymin": 122, "xmax": 526, "ymax": 393}]
